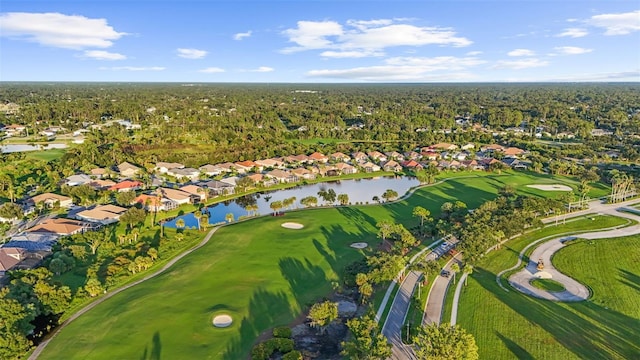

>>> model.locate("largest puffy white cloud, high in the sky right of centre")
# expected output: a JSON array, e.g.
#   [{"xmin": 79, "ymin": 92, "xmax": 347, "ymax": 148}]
[{"xmin": 281, "ymin": 19, "xmax": 472, "ymax": 57}]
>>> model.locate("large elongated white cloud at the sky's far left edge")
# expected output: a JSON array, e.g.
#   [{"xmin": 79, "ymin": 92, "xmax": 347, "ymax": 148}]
[{"xmin": 0, "ymin": 12, "xmax": 126, "ymax": 49}]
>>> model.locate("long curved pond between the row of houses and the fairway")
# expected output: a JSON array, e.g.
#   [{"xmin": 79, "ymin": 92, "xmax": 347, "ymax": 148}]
[{"xmin": 165, "ymin": 176, "xmax": 420, "ymax": 228}]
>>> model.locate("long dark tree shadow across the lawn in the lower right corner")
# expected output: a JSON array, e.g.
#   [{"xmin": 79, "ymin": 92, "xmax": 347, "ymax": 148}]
[{"xmin": 474, "ymin": 268, "xmax": 640, "ymax": 359}]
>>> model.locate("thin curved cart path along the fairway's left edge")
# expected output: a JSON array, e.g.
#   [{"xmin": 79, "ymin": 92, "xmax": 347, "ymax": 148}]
[{"xmin": 29, "ymin": 226, "xmax": 220, "ymax": 360}]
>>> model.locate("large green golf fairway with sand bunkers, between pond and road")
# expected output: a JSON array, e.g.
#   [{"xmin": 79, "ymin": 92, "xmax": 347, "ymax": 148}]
[{"xmin": 41, "ymin": 172, "xmax": 608, "ymax": 359}]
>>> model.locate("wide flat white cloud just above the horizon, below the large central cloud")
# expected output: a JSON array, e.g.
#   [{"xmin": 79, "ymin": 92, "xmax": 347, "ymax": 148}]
[{"xmin": 307, "ymin": 56, "xmax": 485, "ymax": 82}]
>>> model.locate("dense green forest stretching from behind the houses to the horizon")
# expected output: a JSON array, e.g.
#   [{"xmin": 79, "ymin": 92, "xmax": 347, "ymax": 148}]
[{"xmin": 0, "ymin": 83, "xmax": 640, "ymax": 168}]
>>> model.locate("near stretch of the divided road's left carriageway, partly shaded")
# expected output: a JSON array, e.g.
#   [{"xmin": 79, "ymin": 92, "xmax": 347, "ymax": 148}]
[{"xmin": 382, "ymin": 271, "xmax": 421, "ymax": 359}]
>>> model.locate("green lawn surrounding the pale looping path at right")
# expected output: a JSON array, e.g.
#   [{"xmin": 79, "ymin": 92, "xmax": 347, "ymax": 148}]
[{"xmin": 458, "ymin": 217, "xmax": 640, "ymax": 359}]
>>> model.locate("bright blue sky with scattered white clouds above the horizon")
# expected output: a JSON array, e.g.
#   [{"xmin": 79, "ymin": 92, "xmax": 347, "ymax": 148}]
[{"xmin": 0, "ymin": 0, "xmax": 640, "ymax": 82}]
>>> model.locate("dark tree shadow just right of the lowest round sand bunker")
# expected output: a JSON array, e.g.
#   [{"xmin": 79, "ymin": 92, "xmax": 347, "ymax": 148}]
[{"xmin": 221, "ymin": 288, "xmax": 296, "ymax": 360}]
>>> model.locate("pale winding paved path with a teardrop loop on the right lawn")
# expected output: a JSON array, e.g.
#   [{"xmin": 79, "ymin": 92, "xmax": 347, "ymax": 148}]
[{"xmin": 509, "ymin": 204, "xmax": 640, "ymax": 301}]
